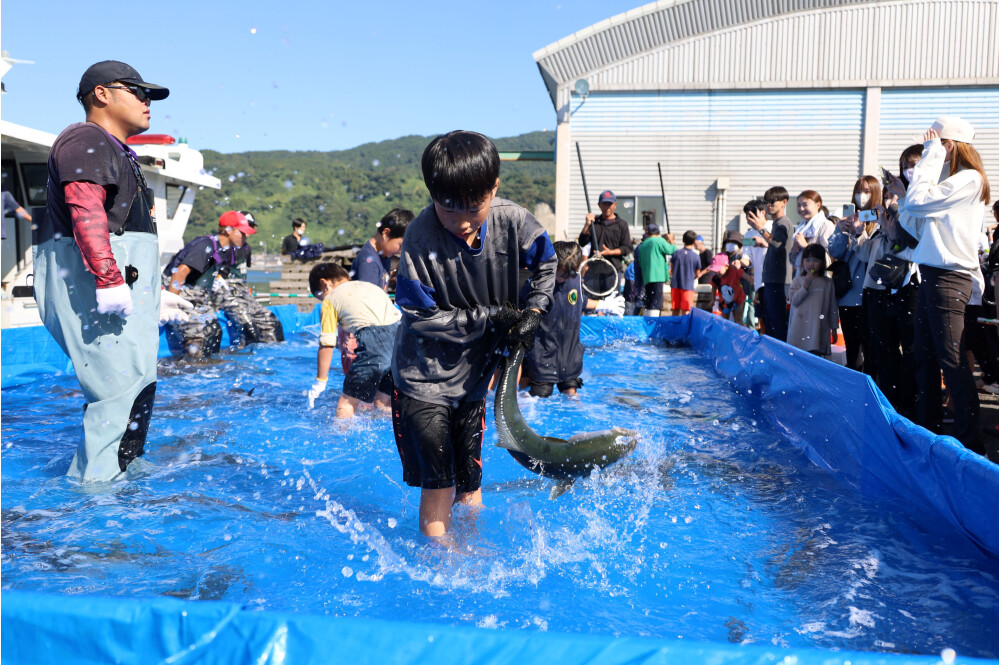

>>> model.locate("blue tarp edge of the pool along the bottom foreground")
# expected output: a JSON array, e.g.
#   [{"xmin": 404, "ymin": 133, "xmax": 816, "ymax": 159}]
[{"xmin": 0, "ymin": 592, "xmax": 989, "ymax": 665}]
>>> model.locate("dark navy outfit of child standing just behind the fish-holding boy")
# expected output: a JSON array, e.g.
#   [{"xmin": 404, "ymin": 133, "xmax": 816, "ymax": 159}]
[{"xmin": 521, "ymin": 275, "xmax": 587, "ymax": 383}]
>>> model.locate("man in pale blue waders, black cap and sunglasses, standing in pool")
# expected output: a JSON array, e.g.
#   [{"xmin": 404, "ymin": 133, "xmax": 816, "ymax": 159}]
[{"xmin": 34, "ymin": 60, "xmax": 169, "ymax": 481}]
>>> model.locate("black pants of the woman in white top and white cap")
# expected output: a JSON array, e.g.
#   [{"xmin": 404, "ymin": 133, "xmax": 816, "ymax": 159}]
[{"xmin": 913, "ymin": 265, "xmax": 983, "ymax": 453}]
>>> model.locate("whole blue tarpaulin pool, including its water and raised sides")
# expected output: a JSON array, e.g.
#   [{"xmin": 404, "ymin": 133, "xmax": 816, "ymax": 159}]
[{"xmin": 0, "ymin": 307, "xmax": 998, "ymax": 664}]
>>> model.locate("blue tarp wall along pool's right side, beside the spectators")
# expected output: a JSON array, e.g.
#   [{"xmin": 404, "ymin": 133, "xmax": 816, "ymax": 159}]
[{"xmin": 581, "ymin": 309, "xmax": 1000, "ymax": 558}]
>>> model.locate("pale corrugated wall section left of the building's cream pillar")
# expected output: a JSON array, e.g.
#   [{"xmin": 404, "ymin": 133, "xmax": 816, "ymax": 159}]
[{"xmin": 560, "ymin": 91, "xmax": 863, "ymax": 244}]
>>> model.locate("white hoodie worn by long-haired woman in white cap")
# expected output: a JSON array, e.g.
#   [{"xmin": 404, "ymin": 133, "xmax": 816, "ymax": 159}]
[{"xmin": 899, "ymin": 139, "xmax": 984, "ymax": 292}]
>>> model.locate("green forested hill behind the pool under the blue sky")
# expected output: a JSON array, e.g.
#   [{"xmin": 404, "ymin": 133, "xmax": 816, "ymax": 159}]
[{"xmin": 184, "ymin": 132, "xmax": 555, "ymax": 252}]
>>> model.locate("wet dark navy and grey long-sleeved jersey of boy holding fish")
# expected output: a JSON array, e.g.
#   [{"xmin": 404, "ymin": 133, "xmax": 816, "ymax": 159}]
[{"xmin": 392, "ymin": 198, "xmax": 557, "ymax": 406}]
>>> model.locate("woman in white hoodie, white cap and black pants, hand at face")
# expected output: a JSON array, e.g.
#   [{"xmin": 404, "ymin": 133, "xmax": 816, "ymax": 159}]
[{"xmin": 899, "ymin": 116, "xmax": 990, "ymax": 452}]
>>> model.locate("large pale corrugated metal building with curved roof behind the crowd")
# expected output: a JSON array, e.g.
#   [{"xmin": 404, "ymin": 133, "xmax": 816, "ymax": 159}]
[{"xmin": 534, "ymin": 0, "xmax": 1000, "ymax": 246}]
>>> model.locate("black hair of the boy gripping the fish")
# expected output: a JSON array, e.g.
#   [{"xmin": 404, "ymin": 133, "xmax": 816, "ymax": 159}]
[{"xmin": 420, "ymin": 130, "xmax": 500, "ymax": 210}]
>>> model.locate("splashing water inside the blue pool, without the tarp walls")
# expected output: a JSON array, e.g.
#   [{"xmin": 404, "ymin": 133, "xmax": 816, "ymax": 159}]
[{"xmin": 0, "ymin": 331, "xmax": 998, "ymax": 658}]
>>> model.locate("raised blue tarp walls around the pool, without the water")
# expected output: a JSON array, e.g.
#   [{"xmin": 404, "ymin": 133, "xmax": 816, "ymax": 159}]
[{"xmin": 0, "ymin": 306, "xmax": 1000, "ymax": 665}]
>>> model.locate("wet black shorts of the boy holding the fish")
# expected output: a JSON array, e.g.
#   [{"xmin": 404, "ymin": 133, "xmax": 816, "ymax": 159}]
[{"xmin": 390, "ymin": 386, "xmax": 486, "ymax": 493}]
